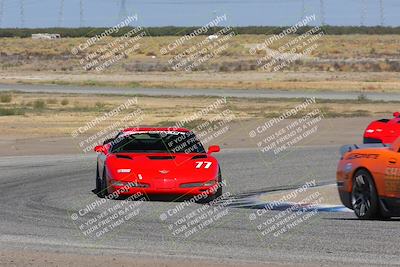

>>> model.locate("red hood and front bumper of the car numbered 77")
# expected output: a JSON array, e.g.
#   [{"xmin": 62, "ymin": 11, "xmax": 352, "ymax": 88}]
[{"xmin": 106, "ymin": 153, "xmax": 218, "ymax": 195}]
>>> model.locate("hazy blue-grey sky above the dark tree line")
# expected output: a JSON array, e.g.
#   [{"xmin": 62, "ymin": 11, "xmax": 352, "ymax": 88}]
[{"xmin": 0, "ymin": 0, "xmax": 400, "ymax": 28}]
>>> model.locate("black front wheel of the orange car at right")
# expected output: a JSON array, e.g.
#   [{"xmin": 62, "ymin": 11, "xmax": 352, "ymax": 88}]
[{"xmin": 351, "ymin": 169, "xmax": 379, "ymax": 220}]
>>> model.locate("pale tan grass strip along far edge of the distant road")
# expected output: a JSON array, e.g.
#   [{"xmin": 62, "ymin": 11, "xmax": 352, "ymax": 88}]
[{"xmin": 0, "ymin": 71, "xmax": 400, "ymax": 92}]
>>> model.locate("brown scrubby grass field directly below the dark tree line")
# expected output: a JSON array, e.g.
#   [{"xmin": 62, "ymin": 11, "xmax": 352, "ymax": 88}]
[{"xmin": 0, "ymin": 35, "xmax": 400, "ymax": 72}]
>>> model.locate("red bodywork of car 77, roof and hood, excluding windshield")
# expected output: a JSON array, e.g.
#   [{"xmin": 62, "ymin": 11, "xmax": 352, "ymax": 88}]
[{"xmin": 98, "ymin": 128, "xmax": 219, "ymax": 199}]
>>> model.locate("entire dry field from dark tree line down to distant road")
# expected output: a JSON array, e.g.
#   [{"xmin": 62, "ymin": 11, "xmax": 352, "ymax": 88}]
[{"xmin": 0, "ymin": 35, "xmax": 400, "ymax": 92}]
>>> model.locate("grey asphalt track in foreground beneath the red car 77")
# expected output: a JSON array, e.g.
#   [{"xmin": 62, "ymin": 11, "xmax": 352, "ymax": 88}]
[{"xmin": 0, "ymin": 146, "xmax": 400, "ymax": 266}]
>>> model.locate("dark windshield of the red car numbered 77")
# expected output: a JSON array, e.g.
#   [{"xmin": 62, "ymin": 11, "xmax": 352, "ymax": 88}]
[{"xmin": 111, "ymin": 132, "xmax": 205, "ymax": 153}]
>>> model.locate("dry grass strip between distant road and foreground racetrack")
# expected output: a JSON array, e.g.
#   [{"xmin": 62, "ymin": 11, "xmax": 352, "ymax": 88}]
[{"xmin": 0, "ymin": 93, "xmax": 399, "ymax": 138}]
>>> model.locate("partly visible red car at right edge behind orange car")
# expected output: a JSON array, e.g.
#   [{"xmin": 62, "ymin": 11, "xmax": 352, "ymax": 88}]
[{"xmin": 364, "ymin": 112, "xmax": 400, "ymax": 144}]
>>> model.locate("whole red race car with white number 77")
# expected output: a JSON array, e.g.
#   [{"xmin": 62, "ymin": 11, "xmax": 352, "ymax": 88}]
[{"xmin": 94, "ymin": 128, "xmax": 222, "ymax": 201}]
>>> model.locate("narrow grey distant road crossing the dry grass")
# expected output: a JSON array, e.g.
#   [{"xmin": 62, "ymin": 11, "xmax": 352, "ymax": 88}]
[{"xmin": 0, "ymin": 84, "xmax": 400, "ymax": 101}]
